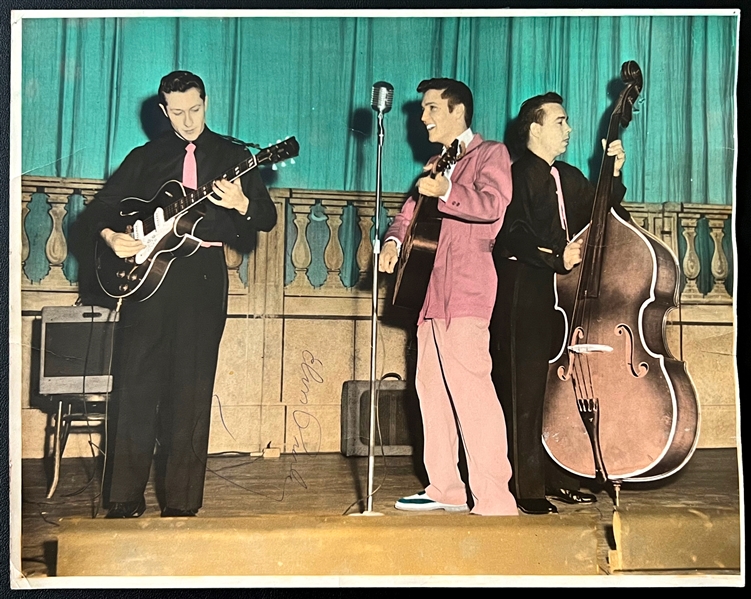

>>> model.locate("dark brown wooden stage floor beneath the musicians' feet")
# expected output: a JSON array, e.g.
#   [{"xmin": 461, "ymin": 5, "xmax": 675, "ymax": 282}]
[{"xmin": 17, "ymin": 449, "xmax": 742, "ymax": 578}]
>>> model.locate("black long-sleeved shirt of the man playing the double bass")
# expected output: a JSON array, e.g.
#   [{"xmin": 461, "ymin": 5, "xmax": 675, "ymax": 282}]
[{"xmin": 494, "ymin": 150, "xmax": 630, "ymax": 273}]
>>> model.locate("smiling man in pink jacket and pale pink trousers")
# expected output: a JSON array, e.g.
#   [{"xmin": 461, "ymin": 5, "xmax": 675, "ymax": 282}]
[{"xmin": 378, "ymin": 78, "xmax": 517, "ymax": 516}]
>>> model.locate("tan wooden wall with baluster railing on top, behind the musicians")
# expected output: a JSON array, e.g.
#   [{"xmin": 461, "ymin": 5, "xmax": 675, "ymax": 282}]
[{"xmin": 21, "ymin": 176, "xmax": 737, "ymax": 457}]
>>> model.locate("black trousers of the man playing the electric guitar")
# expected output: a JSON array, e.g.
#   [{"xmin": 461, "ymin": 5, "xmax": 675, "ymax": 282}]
[{"xmin": 107, "ymin": 247, "xmax": 227, "ymax": 510}]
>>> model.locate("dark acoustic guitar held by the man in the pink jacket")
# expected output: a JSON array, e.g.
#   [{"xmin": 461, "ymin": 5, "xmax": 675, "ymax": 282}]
[{"xmin": 392, "ymin": 139, "xmax": 459, "ymax": 310}]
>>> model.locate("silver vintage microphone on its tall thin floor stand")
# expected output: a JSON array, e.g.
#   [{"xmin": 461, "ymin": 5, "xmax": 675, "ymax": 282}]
[{"xmin": 361, "ymin": 81, "xmax": 394, "ymax": 516}]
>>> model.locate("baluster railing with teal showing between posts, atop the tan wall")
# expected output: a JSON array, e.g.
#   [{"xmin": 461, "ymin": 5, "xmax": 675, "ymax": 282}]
[{"xmin": 22, "ymin": 177, "xmax": 733, "ymax": 304}]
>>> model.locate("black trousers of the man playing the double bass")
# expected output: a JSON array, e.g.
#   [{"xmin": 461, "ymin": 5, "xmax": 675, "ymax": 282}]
[{"xmin": 490, "ymin": 258, "xmax": 579, "ymax": 499}]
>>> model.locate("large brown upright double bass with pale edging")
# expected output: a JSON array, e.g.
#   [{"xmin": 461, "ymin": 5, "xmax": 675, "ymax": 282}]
[{"xmin": 543, "ymin": 61, "xmax": 699, "ymax": 504}]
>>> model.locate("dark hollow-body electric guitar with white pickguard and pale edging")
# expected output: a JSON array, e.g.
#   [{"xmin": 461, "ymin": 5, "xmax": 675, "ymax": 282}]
[{"xmin": 95, "ymin": 137, "xmax": 300, "ymax": 301}]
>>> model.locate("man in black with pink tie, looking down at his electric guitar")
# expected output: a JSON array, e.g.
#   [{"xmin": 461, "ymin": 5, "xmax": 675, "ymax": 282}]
[{"xmin": 90, "ymin": 71, "xmax": 276, "ymax": 518}]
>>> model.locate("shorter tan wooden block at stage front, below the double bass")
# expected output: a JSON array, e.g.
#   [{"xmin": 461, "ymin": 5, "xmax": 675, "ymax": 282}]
[{"xmin": 610, "ymin": 507, "xmax": 741, "ymax": 571}]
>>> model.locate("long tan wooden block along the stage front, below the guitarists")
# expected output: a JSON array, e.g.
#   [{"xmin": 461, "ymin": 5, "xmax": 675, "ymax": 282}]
[{"xmin": 57, "ymin": 512, "xmax": 598, "ymax": 576}]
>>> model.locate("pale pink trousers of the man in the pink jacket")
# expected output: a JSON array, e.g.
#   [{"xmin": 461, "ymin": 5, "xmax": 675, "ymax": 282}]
[{"xmin": 416, "ymin": 317, "xmax": 517, "ymax": 516}]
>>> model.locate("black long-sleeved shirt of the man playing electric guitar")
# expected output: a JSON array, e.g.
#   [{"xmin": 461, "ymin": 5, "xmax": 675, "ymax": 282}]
[{"xmin": 91, "ymin": 127, "xmax": 276, "ymax": 252}]
